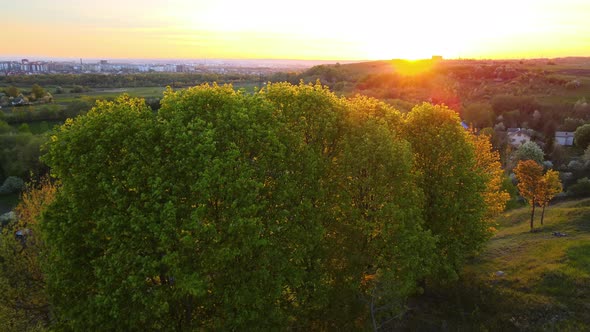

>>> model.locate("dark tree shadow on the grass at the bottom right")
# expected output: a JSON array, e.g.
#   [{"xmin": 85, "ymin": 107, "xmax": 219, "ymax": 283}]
[{"xmin": 390, "ymin": 275, "xmax": 585, "ymax": 331}]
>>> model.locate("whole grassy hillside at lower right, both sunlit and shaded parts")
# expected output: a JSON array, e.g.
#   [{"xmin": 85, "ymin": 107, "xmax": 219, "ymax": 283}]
[{"xmin": 398, "ymin": 199, "xmax": 590, "ymax": 331}]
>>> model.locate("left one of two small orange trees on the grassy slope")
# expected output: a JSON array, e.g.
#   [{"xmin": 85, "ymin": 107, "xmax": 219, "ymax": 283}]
[{"xmin": 514, "ymin": 160, "xmax": 543, "ymax": 232}]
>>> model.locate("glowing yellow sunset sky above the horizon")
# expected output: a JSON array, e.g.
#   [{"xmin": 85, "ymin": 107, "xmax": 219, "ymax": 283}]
[{"xmin": 0, "ymin": 0, "xmax": 590, "ymax": 60}]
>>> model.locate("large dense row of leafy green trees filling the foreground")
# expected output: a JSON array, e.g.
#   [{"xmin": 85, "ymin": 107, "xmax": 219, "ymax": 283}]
[{"xmin": 0, "ymin": 83, "xmax": 508, "ymax": 331}]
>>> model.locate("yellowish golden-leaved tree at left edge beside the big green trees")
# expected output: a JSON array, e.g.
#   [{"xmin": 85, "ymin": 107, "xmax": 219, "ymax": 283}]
[{"xmin": 0, "ymin": 178, "xmax": 56, "ymax": 331}]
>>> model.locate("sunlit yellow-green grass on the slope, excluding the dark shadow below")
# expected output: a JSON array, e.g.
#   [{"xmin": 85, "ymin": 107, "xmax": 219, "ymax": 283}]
[{"xmin": 474, "ymin": 199, "xmax": 590, "ymax": 328}]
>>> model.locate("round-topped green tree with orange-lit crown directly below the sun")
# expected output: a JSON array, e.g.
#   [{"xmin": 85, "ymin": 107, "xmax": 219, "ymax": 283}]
[{"xmin": 405, "ymin": 103, "xmax": 491, "ymax": 279}]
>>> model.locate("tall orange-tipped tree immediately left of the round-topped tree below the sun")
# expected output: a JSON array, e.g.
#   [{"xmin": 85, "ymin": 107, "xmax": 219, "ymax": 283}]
[{"xmin": 336, "ymin": 97, "xmax": 435, "ymax": 330}]
